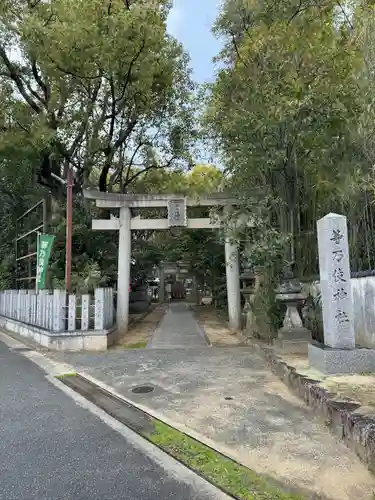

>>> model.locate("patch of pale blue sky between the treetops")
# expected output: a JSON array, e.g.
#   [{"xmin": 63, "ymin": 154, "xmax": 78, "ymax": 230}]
[{"xmin": 168, "ymin": 0, "xmax": 221, "ymax": 83}]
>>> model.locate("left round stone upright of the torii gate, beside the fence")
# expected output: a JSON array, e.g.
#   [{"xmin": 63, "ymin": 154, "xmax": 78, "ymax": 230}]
[{"xmin": 116, "ymin": 207, "xmax": 131, "ymax": 335}]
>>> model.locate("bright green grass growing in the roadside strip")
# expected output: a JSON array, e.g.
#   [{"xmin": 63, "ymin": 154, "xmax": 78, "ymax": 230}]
[{"xmin": 145, "ymin": 421, "xmax": 304, "ymax": 500}]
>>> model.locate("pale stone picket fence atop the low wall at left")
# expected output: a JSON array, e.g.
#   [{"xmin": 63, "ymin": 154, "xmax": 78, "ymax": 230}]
[{"xmin": 0, "ymin": 288, "xmax": 114, "ymax": 332}]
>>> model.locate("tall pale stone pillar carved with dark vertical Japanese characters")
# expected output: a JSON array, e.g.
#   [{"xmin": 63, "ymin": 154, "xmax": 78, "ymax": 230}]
[{"xmin": 317, "ymin": 213, "xmax": 355, "ymax": 349}]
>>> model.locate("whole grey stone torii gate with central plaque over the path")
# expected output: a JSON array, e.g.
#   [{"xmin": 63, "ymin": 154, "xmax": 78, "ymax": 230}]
[{"xmin": 84, "ymin": 190, "xmax": 241, "ymax": 334}]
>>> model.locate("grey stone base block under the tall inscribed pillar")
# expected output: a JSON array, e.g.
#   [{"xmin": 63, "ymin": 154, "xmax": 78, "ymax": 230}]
[{"xmin": 308, "ymin": 343, "xmax": 375, "ymax": 375}]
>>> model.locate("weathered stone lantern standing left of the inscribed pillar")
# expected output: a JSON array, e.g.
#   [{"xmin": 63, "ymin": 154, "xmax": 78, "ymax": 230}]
[{"xmin": 274, "ymin": 263, "xmax": 311, "ymax": 353}]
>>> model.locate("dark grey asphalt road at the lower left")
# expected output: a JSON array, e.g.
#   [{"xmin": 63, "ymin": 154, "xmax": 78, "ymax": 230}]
[{"xmin": 0, "ymin": 342, "xmax": 226, "ymax": 500}]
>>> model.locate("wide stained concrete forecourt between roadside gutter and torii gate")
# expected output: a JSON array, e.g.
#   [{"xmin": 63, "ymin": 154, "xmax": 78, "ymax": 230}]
[{"xmin": 47, "ymin": 347, "xmax": 375, "ymax": 500}]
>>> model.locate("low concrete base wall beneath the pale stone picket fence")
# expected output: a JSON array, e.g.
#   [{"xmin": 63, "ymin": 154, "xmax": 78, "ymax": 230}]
[{"xmin": 0, "ymin": 316, "xmax": 117, "ymax": 351}]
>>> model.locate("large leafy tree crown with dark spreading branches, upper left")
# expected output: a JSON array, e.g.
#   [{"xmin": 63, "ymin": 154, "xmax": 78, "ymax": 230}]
[{"xmin": 0, "ymin": 0, "xmax": 193, "ymax": 193}]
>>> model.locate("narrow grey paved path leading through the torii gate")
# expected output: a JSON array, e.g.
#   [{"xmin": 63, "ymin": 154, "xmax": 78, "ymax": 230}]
[{"xmin": 148, "ymin": 302, "xmax": 207, "ymax": 349}]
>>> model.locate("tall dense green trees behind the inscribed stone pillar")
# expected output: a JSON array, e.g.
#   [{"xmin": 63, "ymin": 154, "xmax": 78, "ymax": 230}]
[{"xmin": 206, "ymin": 0, "xmax": 370, "ymax": 275}]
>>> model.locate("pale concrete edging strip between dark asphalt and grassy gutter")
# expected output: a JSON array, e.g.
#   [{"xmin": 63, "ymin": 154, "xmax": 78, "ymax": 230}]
[{"xmin": 47, "ymin": 375, "xmax": 231, "ymax": 500}]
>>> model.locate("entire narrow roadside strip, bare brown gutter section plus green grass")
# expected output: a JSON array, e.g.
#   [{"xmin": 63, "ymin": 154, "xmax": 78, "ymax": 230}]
[{"xmin": 57, "ymin": 373, "xmax": 310, "ymax": 500}]
